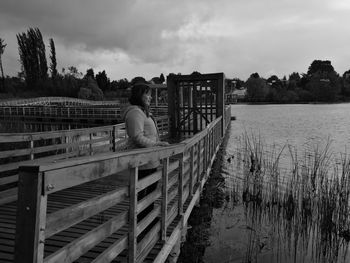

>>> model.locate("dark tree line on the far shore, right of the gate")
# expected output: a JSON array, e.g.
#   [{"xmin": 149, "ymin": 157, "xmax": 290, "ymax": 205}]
[{"xmin": 230, "ymin": 60, "xmax": 350, "ymax": 103}]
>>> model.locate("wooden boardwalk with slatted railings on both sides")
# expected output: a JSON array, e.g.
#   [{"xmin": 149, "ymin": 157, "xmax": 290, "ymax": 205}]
[{"xmin": 0, "ymin": 72, "xmax": 230, "ymax": 263}]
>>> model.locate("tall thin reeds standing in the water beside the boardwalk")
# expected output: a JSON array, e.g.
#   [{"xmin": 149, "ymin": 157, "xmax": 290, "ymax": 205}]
[{"xmin": 235, "ymin": 133, "xmax": 350, "ymax": 262}]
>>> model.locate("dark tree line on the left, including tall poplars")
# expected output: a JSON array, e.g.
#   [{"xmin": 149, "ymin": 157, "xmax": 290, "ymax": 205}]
[{"xmin": 0, "ymin": 28, "xmax": 165, "ymax": 100}]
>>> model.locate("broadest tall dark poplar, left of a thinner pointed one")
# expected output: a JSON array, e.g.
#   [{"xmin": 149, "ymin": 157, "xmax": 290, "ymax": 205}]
[{"xmin": 16, "ymin": 28, "xmax": 48, "ymax": 88}]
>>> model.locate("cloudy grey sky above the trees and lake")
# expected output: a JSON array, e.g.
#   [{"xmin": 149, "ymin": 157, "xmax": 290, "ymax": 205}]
[{"xmin": 0, "ymin": 0, "xmax": 350, "ymax": 80}]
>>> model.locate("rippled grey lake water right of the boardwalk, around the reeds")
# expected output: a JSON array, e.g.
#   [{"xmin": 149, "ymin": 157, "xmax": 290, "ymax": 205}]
[{"xmin": 202, "ymin": 104, "xmax": 350, "ymax": 263}]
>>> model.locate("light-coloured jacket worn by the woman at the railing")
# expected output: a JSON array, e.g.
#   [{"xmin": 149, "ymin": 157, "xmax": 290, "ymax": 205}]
[{"xmin": 124, "ymin": 105, "xmax": 160, "ymax": 170}]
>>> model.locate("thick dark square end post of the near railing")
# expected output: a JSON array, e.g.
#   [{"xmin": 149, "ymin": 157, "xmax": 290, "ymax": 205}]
[{"xmin": 15, "ymin": 167, "xmax": 47, "ymax": 263}]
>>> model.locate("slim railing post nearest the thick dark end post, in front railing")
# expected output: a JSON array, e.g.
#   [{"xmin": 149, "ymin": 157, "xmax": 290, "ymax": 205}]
[{"xmin": 128, "ymin": 167, "xmax": 138, "ymax": 263}]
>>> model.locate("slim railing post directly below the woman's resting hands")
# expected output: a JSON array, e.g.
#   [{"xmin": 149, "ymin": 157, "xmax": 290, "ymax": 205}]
[{"xmin": 161, "ymin": 158, "xmax": 169, "ymax": 241}]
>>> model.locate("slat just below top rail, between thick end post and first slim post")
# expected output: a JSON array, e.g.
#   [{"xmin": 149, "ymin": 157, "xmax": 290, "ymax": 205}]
[{"xmin": 45, "ymin": 187, "xmax": 128, "ymax": 238}]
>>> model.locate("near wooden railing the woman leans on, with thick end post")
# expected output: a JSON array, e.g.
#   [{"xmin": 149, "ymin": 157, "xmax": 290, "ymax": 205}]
[{"xmin": 15, "ymin": 117, "xmax": 223, "ymax": 262}]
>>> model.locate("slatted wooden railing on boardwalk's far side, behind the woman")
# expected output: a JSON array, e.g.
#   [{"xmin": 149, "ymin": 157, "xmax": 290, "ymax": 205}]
[{"xmin": 0, "ymin": 117, "xmax": 169, "ymax": 205}]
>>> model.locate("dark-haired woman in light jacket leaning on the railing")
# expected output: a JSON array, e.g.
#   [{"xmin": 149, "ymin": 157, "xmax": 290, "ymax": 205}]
[{"xmin": 124, "ymin": 83, "xmax": 169, "ymax": 235}]
